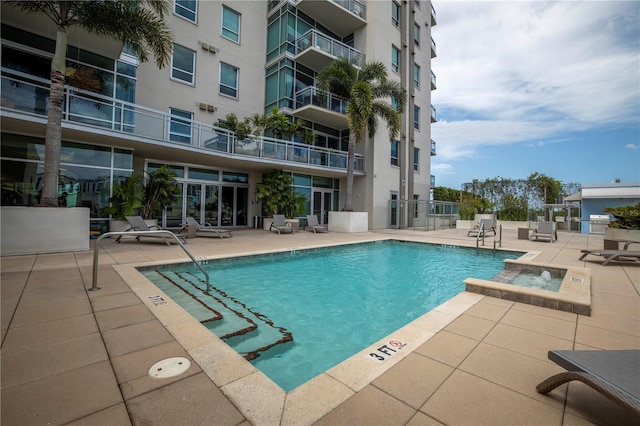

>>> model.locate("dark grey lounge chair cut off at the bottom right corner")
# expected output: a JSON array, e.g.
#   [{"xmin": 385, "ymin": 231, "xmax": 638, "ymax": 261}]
[{"xmin": 536, "ymin": 350, "xmax": 640, "ymax": 415}]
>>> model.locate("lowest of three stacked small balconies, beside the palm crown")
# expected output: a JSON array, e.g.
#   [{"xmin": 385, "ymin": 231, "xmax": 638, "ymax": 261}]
[{"xmin": 293, "ymin": 86, "xmax": 348, "ymax": 130}]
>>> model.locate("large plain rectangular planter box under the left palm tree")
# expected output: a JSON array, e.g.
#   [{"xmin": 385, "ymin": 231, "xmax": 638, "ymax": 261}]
[{"xmin": 0, "ymin": 206, "xmax": 89, "ymax": 256}]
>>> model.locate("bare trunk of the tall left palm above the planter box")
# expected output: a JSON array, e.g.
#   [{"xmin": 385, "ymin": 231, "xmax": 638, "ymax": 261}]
[{"xmin": 40, "ymin": 28, "xmax": 67, "ymax": 207}]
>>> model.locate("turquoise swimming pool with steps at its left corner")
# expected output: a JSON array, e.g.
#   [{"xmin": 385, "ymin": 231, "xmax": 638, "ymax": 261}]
[{"xmin": 141, "ymin": 241, "xmax": 521, "ymax": 391}]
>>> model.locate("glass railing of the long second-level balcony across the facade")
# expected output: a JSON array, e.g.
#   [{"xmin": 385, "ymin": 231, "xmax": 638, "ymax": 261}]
[{"xmin": 1, "ymin": 69, "xmax": 364, "ymax": 171}]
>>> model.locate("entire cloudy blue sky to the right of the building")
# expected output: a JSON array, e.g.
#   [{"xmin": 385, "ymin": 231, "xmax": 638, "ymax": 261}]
[{"xmin": 431, "ymin": 0, "xmax": 640, "ymax": 189}]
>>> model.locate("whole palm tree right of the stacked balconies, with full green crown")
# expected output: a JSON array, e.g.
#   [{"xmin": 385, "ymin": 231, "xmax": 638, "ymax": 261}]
[{"xmin": 316, "ymin": 59, "xmax": 407, "ymax": 211}]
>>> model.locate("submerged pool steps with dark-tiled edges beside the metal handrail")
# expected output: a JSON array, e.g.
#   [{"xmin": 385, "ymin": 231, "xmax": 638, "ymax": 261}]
[{"xmin": 145, "ymin": 269, "xmax": 293, "ymax": 360}]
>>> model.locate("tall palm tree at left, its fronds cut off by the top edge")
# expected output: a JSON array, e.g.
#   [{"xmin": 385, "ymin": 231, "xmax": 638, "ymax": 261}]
[{"xmin": 6, "ymin": 0, "xmax": 173, "ymax": 206}]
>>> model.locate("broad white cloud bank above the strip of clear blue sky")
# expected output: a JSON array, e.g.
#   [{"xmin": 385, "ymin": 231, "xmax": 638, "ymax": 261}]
[{"xmin": 432, "ymin": 1, "xmax": 640, "ymax": 159}]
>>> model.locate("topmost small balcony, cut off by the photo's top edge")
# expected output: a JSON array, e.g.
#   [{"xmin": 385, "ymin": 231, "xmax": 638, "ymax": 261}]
[{"xmin": 296, "ymin": 0, "xmax": 367, "ymax": 37}]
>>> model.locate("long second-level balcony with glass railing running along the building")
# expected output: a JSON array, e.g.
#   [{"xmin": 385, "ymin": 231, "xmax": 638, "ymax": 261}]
[{"xmin": 0, "ymin": 68, "xmax": 364, "ymax": 174}]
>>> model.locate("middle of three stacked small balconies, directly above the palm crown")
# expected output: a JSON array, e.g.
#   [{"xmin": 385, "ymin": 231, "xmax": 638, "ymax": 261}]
[{"xmin": 295, "ymin": 30, "xmax": 366, "ymax": 71}]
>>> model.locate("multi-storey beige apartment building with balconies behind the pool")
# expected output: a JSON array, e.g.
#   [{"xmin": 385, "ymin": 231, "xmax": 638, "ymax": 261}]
[{"xmin": 0, "ymin": 0, "xmax": 436, "ymax": 232}]
